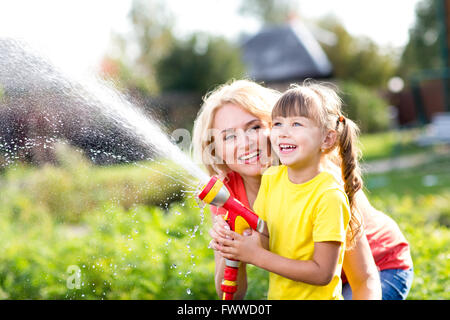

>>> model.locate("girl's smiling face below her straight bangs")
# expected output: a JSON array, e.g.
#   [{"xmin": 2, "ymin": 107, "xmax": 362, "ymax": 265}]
[{"xmin": 270, "ymin": 116, "xmax": 324, "ymax": 168}]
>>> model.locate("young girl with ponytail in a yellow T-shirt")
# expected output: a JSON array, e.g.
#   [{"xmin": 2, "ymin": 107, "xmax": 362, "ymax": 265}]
[{"xmin": 217, "ymin": 84, "xmax": 362, "ymax": 299}]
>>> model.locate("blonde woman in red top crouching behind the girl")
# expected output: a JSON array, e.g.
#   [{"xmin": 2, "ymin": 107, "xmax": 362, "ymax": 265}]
[{"xmin": 193, "ymin": 80, "xmax": 412, "ymax": 299}]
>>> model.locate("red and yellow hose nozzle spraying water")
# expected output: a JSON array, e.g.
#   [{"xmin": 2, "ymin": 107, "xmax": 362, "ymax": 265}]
[{"xmin": 198, "ymin": 176, "xmax": 266, "ymax": 300}]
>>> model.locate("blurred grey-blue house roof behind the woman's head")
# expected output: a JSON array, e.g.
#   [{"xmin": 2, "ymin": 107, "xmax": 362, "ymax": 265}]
[{"xmin": 242, "ymin": 22, "xmax": 332, "ymax": 82}]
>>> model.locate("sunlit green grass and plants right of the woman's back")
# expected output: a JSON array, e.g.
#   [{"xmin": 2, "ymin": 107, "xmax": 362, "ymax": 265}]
[{"xmin": 365, "ymin": 156, "xmax": 450, "ymax": 300}]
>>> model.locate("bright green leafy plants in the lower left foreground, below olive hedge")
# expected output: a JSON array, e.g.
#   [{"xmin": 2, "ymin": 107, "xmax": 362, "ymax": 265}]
[{"xmin": 0, "ymin": 199, "xmax": 215, "ymax": 299}]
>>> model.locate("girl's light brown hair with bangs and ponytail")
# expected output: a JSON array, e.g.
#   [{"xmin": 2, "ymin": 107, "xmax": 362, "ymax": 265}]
[{"xmin": 272, "ymin": 80, "xmax": 363, "ymax": 247}]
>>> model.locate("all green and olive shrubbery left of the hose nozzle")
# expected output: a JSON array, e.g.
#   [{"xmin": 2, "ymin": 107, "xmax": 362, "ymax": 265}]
[{"xmin": 0, "ymin": 150, "xmax": 267, "ymax": 299}]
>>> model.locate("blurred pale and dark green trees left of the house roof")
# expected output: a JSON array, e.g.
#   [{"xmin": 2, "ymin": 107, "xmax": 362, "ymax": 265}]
[{"xmin": 108, "ymin": 0, "xmax": 244, "ymax": 95}]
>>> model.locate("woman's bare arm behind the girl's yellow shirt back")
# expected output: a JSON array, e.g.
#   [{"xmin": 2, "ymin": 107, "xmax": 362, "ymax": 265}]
[{"xmin": 343, "ymin": 231, "xmax": 381, "ymax": 300}]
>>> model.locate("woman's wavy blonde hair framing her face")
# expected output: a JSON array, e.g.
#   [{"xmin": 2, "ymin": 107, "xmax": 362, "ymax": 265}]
[{"xmin": 192, "ymin": 79, "xmax": 281, "ymax": 175}]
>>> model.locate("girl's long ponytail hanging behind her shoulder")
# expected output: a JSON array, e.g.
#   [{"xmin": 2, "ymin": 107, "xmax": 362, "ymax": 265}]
[{"xmin": 336, "ymin": 116, "xmax": 363, "ymax": 244}]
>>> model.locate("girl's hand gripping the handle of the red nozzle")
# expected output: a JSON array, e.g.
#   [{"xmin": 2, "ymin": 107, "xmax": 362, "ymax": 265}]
[{"xmin": 216, "ymin": 229, "xmax": 267, "ymax": 264}]
